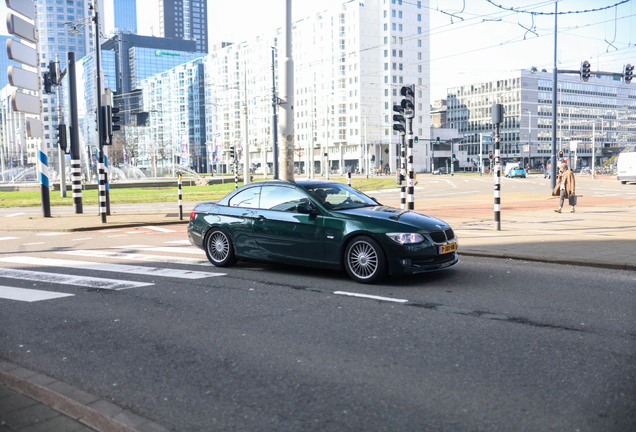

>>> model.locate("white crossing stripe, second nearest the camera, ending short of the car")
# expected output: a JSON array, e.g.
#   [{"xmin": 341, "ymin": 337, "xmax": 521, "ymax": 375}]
[{"xmin": 0, "ymin": 268, "xmax": 154, "ymax": 290}]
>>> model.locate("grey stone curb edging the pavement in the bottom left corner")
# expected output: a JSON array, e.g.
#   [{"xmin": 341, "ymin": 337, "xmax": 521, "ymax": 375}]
[{"xmin": 0, "ymin": 362, "xmax": 168, "ymax": 432}]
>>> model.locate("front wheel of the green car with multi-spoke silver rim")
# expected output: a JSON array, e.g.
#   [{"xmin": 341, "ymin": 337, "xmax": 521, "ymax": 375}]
[{"xmin": 344, "ymin": 236, "xmax": 387, "ymax": 284}]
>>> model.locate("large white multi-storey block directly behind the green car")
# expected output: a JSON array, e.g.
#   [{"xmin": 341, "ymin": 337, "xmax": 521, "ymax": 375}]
[{"xmin": 204, "ymin": 0, "xmax": 430, "ymax": 173}]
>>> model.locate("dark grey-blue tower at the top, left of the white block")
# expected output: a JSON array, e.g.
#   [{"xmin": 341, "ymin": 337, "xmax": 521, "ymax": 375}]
[{"xmin": 159, "ymin": 0, "xmax": 208, "ymax": 53}]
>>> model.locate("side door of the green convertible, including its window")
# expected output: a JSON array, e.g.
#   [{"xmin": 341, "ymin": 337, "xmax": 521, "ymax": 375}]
[{"xmin": 252, "ymin": 185, "xmax": 325, "ymax": 261}]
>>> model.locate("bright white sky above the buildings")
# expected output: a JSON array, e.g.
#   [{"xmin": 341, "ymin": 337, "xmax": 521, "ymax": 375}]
[{"xmin": 0, "ymin": 0, "xmax": 636, "ymax": 101}]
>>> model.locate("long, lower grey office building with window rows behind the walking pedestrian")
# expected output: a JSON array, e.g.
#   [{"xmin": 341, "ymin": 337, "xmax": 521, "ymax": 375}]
[{"xmin": 447, "ymin": 70, "xmax": 636, "ymax": 170}]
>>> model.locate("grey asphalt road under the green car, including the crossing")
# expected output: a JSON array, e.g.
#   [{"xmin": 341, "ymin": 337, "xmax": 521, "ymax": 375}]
[{"xmin": 0, "ymin": 227, "xmax": 636, "ymax": 431}]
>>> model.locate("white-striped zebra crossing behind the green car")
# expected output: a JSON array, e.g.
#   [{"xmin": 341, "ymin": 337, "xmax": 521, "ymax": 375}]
[{"xmin": 0, "ymin": 241, "xmax": 219, "ymax": 302}]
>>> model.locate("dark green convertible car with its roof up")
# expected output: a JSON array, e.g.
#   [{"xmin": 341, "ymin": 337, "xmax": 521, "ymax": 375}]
[{"xmin": 188, "ymin": 180, "xmax": 458, "ymax": 283}]
